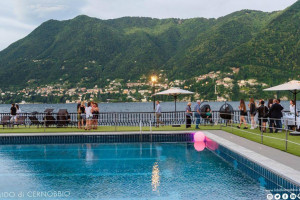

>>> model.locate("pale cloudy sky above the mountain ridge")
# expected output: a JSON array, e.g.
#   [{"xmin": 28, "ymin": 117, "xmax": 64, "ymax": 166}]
[{"xmin": 0, "ymin": 0, "xmax": 297, "ymax": 51}]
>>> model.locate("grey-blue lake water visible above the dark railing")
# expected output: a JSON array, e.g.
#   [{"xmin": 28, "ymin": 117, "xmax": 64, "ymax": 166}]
[{"xmin": 0, "ymin": 101, "xmax": 300, "ymax": 113}]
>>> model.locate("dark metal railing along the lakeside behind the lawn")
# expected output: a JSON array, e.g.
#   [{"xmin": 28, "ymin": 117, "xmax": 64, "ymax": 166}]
[{"xmin": 0, "ymin": 110, "xmax": 296, "ymax": 128}]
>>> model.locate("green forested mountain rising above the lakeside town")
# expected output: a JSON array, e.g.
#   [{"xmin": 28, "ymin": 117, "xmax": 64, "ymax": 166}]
[{"xmin": 0, "ymin": 1, "xmax": 300, "ymax": 101}]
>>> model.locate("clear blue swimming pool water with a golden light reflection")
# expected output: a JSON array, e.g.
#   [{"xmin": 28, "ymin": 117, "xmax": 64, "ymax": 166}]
[{"xmin": 0, "ymin": 143, "xmax": 266, "ymax": 200}]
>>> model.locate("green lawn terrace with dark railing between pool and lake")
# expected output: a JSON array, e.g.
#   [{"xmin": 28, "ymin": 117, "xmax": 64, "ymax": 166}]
[{"xmin": 0, "ymin": 111, "xmax": 300, "ymax": 156}]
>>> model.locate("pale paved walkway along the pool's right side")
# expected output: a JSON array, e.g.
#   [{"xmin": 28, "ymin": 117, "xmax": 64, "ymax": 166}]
[{"xmin": 203, "ymin": 130, "xmax": 300, "ymax": 186}]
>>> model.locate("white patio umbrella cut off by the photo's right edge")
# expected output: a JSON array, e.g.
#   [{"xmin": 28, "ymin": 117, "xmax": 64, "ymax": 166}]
[{"xmin": 264, "ymin": 80, "xmax": 300, "ymax": 134}]
